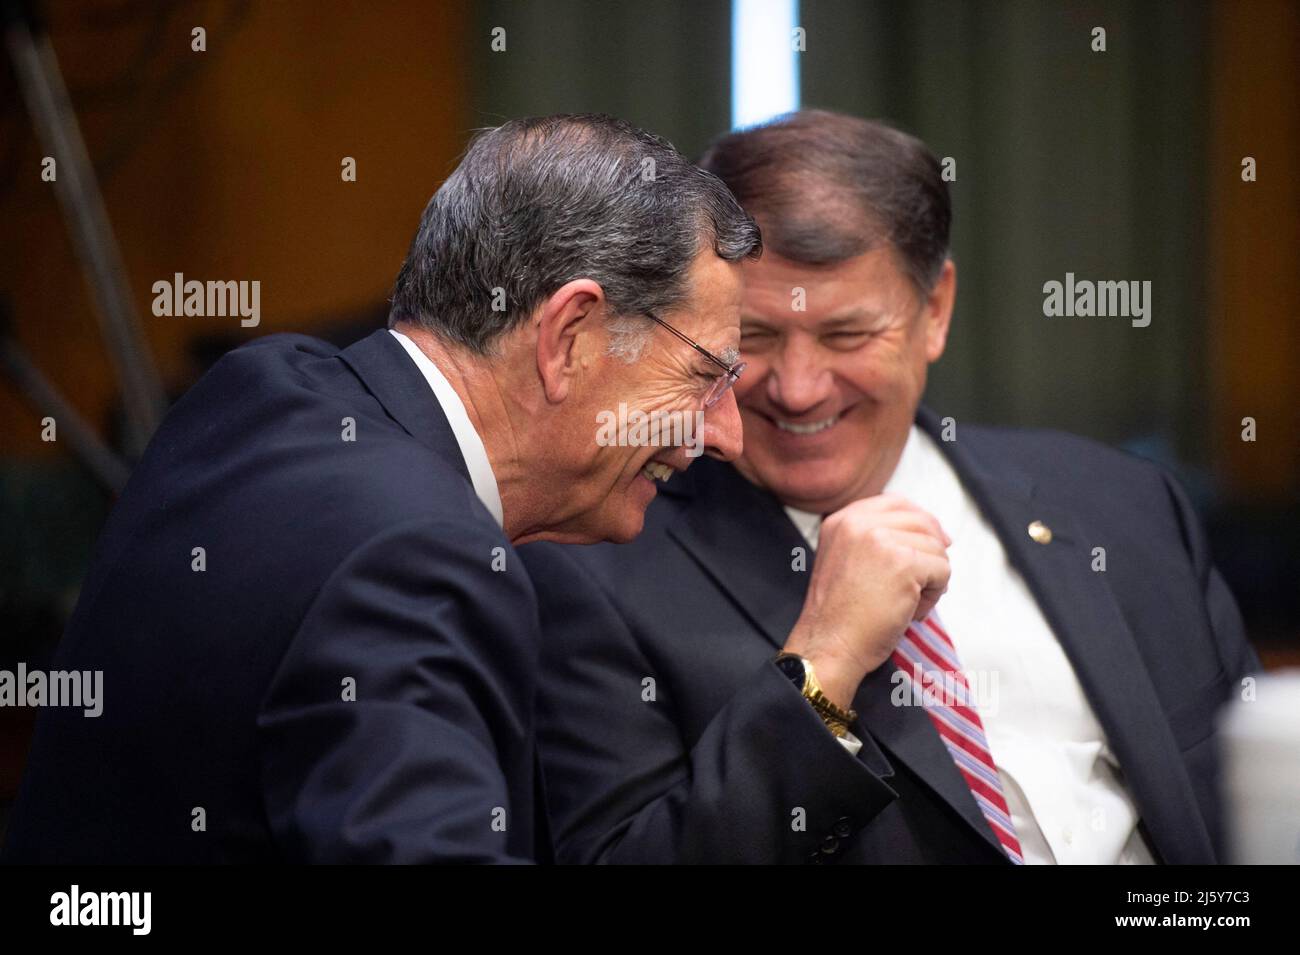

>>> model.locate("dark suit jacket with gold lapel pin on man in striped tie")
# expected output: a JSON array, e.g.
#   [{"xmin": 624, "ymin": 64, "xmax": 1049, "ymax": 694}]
[{"xmin": 520, "ymin": 409, "xmax": 1258, "ymax": 863}]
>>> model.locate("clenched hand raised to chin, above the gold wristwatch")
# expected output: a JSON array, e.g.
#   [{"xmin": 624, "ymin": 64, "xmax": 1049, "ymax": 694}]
[{"xmin": 785, "ymin": 494, "xmax": 952, "ymax": 709}]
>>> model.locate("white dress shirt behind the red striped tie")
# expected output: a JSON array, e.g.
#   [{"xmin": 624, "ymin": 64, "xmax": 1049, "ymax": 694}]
[{"xmin": 785, "ymin": 426, "xmax": 1153, "ymax": 864}]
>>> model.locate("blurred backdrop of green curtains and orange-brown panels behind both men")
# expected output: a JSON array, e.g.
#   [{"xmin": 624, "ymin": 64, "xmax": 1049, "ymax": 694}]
[{"xmin": 0, "ymin": 0, "xmax": 1300, "ymax": 829}]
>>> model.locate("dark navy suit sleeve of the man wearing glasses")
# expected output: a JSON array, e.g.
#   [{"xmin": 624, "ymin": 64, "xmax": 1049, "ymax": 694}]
[{"xmin": 257, "ymin": 521, "xmax": 537, "ymax": 863}]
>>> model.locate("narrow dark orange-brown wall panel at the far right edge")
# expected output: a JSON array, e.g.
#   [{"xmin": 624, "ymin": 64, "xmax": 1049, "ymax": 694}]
[{"xmin": 1206, "ymin": 0, "xmax": 1300, "ymax": 503}]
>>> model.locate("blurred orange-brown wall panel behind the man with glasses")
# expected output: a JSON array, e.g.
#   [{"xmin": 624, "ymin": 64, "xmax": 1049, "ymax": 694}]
[{"xmin": 0, "ymin": 0, "xmax": 471, "ymax": 455}]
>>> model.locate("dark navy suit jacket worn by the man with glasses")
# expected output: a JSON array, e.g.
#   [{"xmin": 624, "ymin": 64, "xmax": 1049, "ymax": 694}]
[{"xmin": 5, "ymin": 331, "xmax": 545, "ymax": 863}]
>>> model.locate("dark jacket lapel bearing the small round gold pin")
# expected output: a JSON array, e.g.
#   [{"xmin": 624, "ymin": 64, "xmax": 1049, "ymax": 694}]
[{"xmin": 918, "ymin": 409, "xmax": 1214, "ymax": 863}]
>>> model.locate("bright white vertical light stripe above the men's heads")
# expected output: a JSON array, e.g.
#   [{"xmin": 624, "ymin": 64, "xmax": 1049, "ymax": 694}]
[{"xmin": 732, "ymin": 0, "xmax": 802, "ymax": 129}]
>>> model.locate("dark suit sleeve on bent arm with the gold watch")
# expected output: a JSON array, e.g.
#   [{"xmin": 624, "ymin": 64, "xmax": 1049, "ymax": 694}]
[{"xmin": 528, "ymin": 547, "xmax": 896, "ymax": 863}]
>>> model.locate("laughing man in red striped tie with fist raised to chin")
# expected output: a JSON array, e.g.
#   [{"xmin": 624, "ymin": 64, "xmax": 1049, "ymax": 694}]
[{"xmin": 523, "ymin": 110, "xmax": 1258, "ymax": 863}]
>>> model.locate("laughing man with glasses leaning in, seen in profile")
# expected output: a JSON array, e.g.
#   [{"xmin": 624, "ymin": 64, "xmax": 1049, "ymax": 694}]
[{"xmin": 5, "ymin": 116, "xmax": 759, "ymax": 863}]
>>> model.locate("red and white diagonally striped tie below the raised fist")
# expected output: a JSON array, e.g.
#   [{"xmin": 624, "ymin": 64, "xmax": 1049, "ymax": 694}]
[{"xmin": 891, "ymin": 613, "xmax": 1024, "ymax": 865}]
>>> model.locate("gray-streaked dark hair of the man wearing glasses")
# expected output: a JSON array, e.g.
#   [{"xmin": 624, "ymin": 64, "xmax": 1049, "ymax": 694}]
[{"xmin": 389, "ymin": 114, "xmax": 762, "ymax": 359}]
